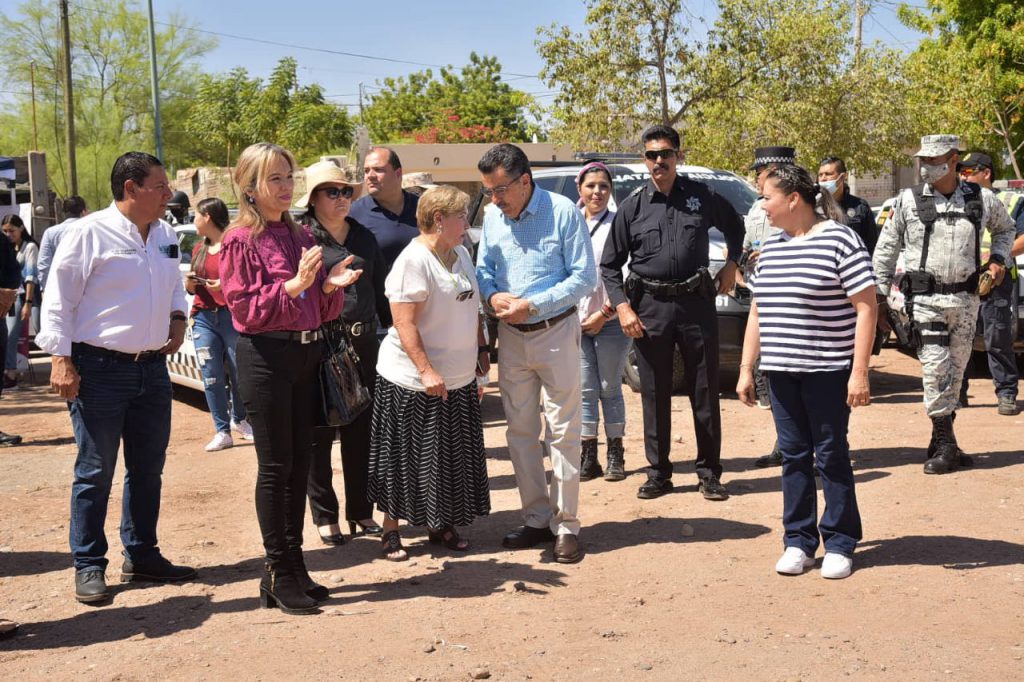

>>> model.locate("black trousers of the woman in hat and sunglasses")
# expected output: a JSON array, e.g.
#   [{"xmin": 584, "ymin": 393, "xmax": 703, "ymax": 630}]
[{"xmin": 306, "ymin": 327, "xmax": 380, "ymax": 525}]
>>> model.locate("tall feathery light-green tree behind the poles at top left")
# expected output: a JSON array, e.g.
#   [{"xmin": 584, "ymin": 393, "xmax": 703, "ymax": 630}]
[{"xmin": 0, "ymin": 0, "xmax": 215, "ymax": 206}]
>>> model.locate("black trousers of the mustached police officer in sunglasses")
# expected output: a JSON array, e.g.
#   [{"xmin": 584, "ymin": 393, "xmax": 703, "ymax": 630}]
[{"xmin": 634, "ymin": 293, "xmax": 722, "ymax": 480}]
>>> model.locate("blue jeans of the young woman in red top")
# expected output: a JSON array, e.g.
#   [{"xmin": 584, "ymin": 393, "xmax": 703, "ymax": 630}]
[{"xmin": 193, "ymin": 307, "xmax": 246, "ymax": 433}]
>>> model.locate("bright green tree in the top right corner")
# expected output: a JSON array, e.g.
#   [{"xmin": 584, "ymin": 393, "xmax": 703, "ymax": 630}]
[{"xmin": 900, "ymin": 0, "xmax": 1024, "ymax": 178}]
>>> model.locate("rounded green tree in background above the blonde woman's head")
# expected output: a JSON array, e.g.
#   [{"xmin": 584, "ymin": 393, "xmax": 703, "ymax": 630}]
[{"xmin": 185, "ymin": 57, "xmax": 352, "ymax": 165}]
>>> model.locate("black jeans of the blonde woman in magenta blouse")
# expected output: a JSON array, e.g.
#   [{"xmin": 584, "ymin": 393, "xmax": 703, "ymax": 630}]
[{"xmin": 236, "ymin": 335, "xmax": 321, "ymax": 561}]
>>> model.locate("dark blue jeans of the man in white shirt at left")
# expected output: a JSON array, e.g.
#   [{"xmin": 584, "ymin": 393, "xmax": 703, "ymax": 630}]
[{"xmin": 69, "ymin": 347, "xmax": 171, "ymax": 570}]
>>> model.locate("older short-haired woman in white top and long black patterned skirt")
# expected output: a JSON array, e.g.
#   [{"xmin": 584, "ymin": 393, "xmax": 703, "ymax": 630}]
[{"xmin": 368, "ymin": 186, "xmax": 490, "ymax": 561}]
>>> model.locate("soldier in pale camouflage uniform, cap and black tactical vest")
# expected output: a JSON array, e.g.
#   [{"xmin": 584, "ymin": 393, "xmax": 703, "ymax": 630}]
[{"xmin": 873, "ymin": 135, "xmax": 1014, "ymax": 474}]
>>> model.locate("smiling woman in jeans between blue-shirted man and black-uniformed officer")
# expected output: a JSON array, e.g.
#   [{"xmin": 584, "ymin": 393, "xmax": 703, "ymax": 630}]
[{"xmin": 577, "ymin": 163, "xmax": 631, "ymax": 480}]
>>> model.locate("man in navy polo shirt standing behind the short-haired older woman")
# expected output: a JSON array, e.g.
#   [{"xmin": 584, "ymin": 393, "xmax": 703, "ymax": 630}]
[{"xmin": 349, "ymin": 146, "xmax": 420, "ymax": 274}]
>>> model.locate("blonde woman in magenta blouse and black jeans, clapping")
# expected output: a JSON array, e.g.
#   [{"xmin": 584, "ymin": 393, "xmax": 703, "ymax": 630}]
[{"xmin": 220, "ymin": 142, "xmax": 359, "ymax": 613}]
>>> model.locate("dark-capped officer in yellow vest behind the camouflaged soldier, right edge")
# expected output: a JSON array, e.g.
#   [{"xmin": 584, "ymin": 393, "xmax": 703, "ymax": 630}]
[{"xmin": 959, "ymin": 152, "xmax": 1024, "ymax": 417}]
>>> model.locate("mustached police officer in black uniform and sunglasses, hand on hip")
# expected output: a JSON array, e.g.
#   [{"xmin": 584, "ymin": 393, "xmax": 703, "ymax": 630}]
[{"xmin": 601, "ymin": 125, "xmax": 743, "ymax": 500}]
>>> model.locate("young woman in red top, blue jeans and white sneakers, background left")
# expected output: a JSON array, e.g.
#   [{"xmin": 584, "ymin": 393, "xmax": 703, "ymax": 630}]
[{"xmin": 185, "ymin": 199, "xmax": 253, "ymax": 453}]
